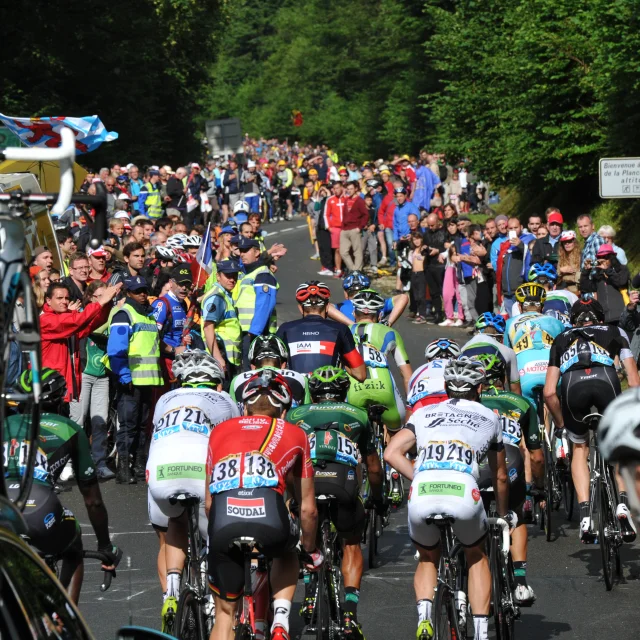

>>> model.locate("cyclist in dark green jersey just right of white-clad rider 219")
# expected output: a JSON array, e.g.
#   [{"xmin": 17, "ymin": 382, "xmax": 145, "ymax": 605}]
[{"xmin": 473, "ymin": 354, "xmax": 544, "ymax": 607}]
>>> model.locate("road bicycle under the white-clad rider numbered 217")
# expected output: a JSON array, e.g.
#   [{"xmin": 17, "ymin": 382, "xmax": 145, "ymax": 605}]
[{"xmin": 165, "ymin": 493, "xmax": 215, "ymax": 640}]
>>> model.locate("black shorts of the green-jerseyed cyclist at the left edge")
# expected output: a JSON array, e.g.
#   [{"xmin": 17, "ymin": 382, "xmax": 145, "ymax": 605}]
[{"xmin": 8, "ymin": 481, "xmax": 82, "ymax": 556}]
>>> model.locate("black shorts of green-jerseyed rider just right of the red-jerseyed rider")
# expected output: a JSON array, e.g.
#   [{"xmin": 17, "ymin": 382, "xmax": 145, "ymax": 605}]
[{"xmin": 313, "ymin": 461, "xmax": 365, "ymax": 538}]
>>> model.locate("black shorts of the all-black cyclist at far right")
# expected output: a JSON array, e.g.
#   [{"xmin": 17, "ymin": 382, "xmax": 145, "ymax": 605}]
[{"xmin": 560, "ymin": 367, "xmax": 622, "ymax": 444}]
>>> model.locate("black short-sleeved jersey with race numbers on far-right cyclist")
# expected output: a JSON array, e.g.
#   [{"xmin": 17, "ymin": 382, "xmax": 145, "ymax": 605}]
[{"xmin": 549, "ymin": 325, "xmax": 633, "ymax": 374}]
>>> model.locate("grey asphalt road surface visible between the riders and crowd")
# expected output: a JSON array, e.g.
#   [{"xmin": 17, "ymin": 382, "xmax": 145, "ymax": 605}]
[{"xmin": 66, "ymin": 220, "xmax": 640, "ymax": 640}]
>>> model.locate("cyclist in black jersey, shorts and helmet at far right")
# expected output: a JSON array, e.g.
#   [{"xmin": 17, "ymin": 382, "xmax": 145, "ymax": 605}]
[{"xmin": 544, "ymin": 299, "xmax": 640, "ymax": 544}]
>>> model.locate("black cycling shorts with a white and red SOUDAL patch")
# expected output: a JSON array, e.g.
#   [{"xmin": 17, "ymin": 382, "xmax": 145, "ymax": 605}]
[{"xmin": 207, "ymin": 488, "xmax": 300, "ymax": 602}]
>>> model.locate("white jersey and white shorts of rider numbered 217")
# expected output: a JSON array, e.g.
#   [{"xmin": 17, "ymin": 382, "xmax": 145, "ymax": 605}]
[{"xmin": 147, "ymin": 387, "xmax": 240, "ymax": 537}]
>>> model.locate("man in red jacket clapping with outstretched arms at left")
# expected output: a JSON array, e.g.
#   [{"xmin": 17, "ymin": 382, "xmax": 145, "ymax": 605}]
[{"xmin": 40, "ymin": 282, "xmax": 122, "ymax": 410}]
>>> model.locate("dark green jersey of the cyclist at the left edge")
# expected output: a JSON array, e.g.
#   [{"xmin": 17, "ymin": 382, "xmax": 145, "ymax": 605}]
[{"xmin": 3, "ymin": 413, "xmax": 98, "ymax": 486}]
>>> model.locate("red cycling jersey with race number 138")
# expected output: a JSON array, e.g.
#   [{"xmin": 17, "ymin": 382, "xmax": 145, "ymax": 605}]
[{"xmin": 207, "ymin": 416, "xmax": 313, "ymax": 495}]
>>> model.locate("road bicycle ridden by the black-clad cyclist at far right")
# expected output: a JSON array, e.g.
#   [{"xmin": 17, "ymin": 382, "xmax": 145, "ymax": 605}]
[{"xmin": 583, "ymin": 413, "xmax": 623, "ymax": 591}]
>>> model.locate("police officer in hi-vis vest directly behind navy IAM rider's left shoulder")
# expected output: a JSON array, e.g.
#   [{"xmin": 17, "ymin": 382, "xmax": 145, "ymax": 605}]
[{"xmin": 233, "ymin": 236, "xmax": 279, "ymax": 371}]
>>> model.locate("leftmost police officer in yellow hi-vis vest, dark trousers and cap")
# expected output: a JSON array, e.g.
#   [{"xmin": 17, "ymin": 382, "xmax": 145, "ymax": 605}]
[{"xmin": 107, "ymin": 276, "xmax": 163, "ymax": 484}]
